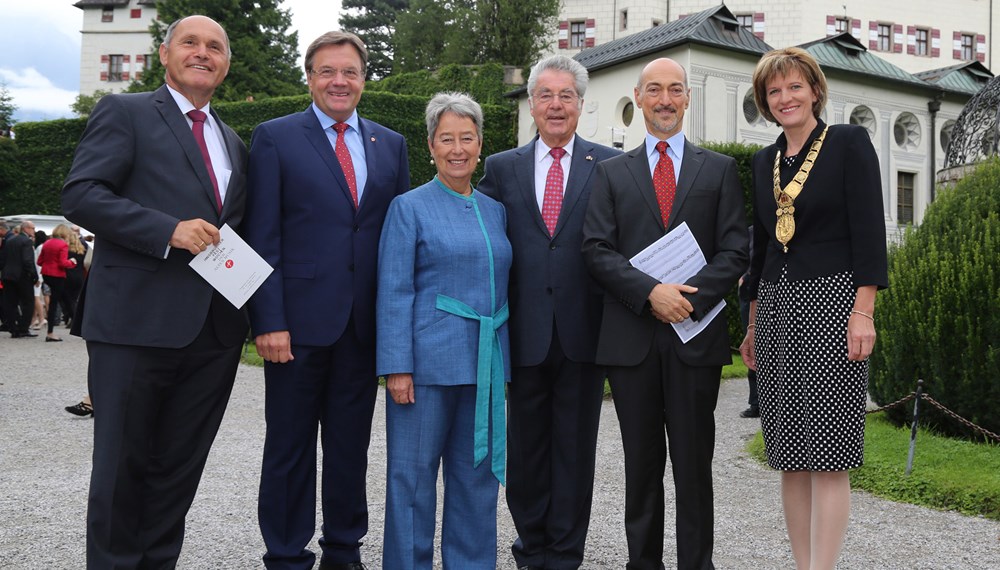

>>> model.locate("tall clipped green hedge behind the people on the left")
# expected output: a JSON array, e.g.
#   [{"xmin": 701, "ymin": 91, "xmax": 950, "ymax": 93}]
[{"xmin": 0, "ymin": 90, "xmax": 517, "ymax": 214}]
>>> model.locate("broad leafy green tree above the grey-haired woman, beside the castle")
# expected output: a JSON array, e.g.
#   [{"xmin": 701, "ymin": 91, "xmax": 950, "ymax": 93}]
[{"xmin": 393, "ymin": 0, "xmax": 560, "ymax": 72}]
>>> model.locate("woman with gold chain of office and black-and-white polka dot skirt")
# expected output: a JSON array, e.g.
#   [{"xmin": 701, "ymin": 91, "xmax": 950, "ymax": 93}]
[{"xmin": 740, "ymin": 48, "xmax": 888, "ymax": 570}]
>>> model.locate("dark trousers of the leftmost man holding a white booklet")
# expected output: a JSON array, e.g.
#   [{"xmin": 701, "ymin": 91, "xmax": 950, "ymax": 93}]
[{"xmin": 86, "ymin": 303, "xmax": 241, "ymax": 569}]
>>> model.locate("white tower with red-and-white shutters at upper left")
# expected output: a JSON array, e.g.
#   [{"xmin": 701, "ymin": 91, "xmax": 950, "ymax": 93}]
[{"xmin": 74, "ymin": 0, "xmax": 158, "ymax": 95}]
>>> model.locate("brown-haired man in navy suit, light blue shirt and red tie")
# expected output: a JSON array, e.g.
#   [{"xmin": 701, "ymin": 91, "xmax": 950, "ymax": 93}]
[{"xmin": 246, "ymin": 32, "xmax": 410, "ymax": 570}]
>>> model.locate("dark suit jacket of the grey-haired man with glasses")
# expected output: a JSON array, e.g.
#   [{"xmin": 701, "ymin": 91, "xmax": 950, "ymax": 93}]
[{"xmin": 478, "ymin": 137, "xmax": 621, "ymax": 366}]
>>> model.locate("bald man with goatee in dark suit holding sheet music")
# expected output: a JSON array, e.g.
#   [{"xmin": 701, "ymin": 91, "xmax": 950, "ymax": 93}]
[{"xmin": 583, "ymin": 59, "xmax": 747, "ymax": 570}]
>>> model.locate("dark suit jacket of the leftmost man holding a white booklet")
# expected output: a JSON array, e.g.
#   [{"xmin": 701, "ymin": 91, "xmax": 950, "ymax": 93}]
[{"xmin": 62, "ymin": 86, "xmax": 248, "ymax": 348}]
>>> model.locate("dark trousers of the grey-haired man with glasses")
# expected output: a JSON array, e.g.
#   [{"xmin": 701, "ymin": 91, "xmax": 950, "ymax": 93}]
[{"xmin": 507, "ymin": 327, "xmax": 604, "ymax": 569}]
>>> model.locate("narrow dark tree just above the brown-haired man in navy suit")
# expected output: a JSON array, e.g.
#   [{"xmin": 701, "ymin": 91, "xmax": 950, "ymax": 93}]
[{"xmin": 340, "ymin": 0, "xmax": 410, "ymax": 79}]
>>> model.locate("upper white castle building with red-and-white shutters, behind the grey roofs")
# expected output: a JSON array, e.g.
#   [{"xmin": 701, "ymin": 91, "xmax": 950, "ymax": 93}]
[{"xmin": 551, "ymin": 0, "xmax": 1000, "ymax": 73}]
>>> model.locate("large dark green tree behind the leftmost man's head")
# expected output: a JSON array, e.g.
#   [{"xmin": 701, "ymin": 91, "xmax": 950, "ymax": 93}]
[{"xmin": 129, "ymin": 0, "xmax": 306, "ymax": 101}]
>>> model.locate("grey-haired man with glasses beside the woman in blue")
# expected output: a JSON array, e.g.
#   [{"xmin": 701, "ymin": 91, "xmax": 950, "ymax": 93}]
[{"xmin": 479, "ymin": 55, "xmax": 620, "ymax": 569}]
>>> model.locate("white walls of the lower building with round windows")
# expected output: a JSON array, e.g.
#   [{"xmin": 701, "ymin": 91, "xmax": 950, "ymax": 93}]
[{"xmin": 518, "ymin": 8, "xmax": 984, "ymax": 233}]
